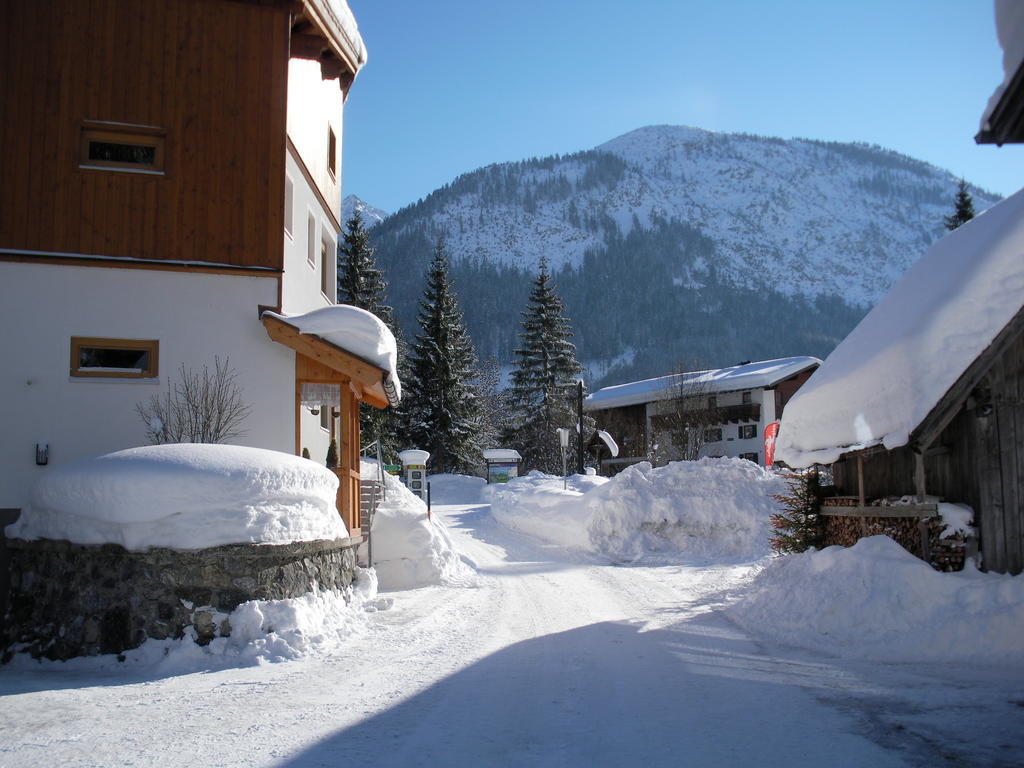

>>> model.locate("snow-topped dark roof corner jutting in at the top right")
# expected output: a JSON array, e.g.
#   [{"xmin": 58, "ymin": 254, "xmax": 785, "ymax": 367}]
[{"xmin": 975, "ymin": 0, "xmax": 1024, "ymax": 144}]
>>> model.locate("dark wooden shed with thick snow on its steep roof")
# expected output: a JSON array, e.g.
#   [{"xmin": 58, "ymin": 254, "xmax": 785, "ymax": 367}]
[{"xmin": 776, "ymin": 190, "xmax": 1024, "ymax": 573}]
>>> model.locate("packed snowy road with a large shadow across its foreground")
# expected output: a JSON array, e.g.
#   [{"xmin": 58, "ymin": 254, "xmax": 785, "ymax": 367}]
[{"xmin": 0, "ymin": 495, "xmax": 1024, "ymax": 768}]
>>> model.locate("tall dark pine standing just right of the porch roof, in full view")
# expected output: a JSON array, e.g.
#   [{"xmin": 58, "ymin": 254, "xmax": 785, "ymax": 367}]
[{"xmin": 402, "ymin": 242, "xmax": 481, "ymax": 472}]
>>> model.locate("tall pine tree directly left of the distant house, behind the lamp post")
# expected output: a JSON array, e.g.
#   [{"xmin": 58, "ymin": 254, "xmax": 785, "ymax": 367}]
[{"xmin": 507, "ymin": 258, "xmax": 589, "ymax": 473}]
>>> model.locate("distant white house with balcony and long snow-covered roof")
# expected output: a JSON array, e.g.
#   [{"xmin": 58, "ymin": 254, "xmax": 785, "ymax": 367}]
[{"xmin": 583, "ymin": 357, "xmax": 821, "ymax": 473}]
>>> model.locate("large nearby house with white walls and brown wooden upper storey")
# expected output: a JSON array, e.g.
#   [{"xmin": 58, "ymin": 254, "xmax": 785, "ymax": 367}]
[{"xmin": 0, "ymin": 0, "xmax": 394, "ymax": 527}]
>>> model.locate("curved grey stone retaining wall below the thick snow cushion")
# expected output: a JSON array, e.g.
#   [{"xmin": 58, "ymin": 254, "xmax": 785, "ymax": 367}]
[{"xmin": 0, "ymin": 539, "xmax": 357, "ymax": 662}]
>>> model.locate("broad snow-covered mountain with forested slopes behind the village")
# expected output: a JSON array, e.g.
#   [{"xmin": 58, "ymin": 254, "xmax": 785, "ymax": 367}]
[{"xmin": 374, "ymin": 126, "xmax": 997, "ymax": 383}]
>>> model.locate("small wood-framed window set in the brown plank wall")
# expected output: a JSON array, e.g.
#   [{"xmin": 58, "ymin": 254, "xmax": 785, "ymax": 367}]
[{"xmin": 78, "ymin": 122, "xmax": 166, "ymax": 174}]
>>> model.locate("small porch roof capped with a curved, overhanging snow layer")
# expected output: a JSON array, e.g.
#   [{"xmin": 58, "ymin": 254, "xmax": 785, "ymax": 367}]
[{"xmin": 261, "ymin": 304, "xmax": 401, "ymax": 408}]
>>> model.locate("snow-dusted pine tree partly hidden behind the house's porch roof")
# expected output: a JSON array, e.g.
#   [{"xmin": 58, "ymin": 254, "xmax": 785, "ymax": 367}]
[{"xmin": 338, "ymin": 213, "xmax": 409, "ymax": 461}]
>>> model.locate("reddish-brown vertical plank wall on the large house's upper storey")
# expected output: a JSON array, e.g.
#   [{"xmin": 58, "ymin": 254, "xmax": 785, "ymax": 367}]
[{"xmin": 0, "ymin": 0, "xmax": 289, "ymax": 268}]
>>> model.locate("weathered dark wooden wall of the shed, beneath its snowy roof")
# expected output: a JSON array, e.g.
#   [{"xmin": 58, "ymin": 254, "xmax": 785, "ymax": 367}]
[{"xmin": 833, "ymin": 309, "xmax": 1024, "ymax": 573}]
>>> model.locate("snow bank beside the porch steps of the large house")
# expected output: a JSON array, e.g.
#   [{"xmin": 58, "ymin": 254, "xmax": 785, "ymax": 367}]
[{"xmin": 362, "ymin": 461, "xmax": 474, "ymax": 590}]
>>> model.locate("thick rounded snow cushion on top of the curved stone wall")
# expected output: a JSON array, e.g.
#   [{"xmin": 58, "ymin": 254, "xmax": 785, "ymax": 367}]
[{"xmin": 6, "ymin": 443, "xmax": 348, "ymax": 551}]
